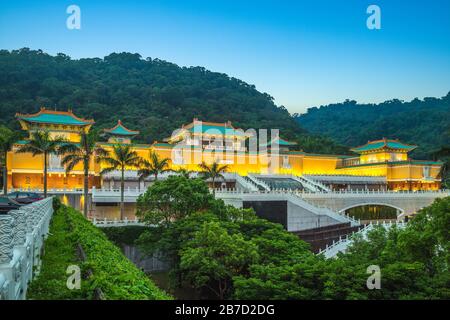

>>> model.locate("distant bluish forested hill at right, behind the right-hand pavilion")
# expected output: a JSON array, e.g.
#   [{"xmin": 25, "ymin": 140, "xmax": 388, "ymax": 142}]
[{"xmin": 296, "ymin": 93, "xmax": 450, "ymax": 158}]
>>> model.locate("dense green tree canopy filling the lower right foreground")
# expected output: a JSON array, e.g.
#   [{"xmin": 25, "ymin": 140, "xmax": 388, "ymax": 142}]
[{"xmin": 132, "ymin": 176, "xmax": 450, "ymax": 300}]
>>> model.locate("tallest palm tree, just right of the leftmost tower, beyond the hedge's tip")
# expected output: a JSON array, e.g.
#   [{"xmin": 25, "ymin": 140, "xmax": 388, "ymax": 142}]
[{"xmin": 58, "ymin": 131, "xmax": 108, "ymax": 217}]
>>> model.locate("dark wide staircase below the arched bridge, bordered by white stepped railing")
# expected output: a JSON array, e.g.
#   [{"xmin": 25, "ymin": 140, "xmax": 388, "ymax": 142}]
[{"xmin": 293, "ymin": 222, "xmax": 364, "ymax": 253}]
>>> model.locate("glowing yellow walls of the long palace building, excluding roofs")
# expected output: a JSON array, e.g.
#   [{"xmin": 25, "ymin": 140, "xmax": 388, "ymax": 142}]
[{"xmin": 8, "ymin": 132, "xmax": 440, "ymax": 190}]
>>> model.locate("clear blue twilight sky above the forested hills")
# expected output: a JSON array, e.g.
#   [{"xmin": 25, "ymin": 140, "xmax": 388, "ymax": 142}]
[{"xmin": 0, "ymin": 0, "xmax": 450, "ymax": 113}]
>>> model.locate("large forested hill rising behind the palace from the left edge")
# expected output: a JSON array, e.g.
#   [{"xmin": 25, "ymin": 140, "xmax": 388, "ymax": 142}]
[{"xmin": 0, "ymin": 48, "xmax": 346, "ymax": 153}]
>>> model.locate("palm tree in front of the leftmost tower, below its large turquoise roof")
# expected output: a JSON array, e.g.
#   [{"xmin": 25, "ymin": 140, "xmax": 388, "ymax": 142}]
[{"xmin": 17, "ymin": 130, "xmax": 67, "ymax": 198}]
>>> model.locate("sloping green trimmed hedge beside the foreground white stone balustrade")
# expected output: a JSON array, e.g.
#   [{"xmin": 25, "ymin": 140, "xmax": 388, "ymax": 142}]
[{"xmin": 27, "ymin": 205, "xmax": 172, "ymax": 300}]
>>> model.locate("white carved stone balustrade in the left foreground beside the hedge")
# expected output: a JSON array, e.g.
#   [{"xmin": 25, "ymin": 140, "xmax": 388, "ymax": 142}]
[{"xmin": 0, "ymin": 198, "xmax": 53, "ymax": 300}]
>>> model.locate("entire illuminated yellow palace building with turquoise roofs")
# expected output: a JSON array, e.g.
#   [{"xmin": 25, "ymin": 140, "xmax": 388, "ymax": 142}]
[{"xmin": 8, "ymin": 109, "xmax": 442, "ymax": 190}]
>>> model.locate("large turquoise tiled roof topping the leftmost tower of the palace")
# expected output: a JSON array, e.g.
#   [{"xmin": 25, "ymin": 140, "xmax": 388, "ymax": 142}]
[{"xmin": 16, "ymin": 108, "xmax": 94, "ymax": 126}]
